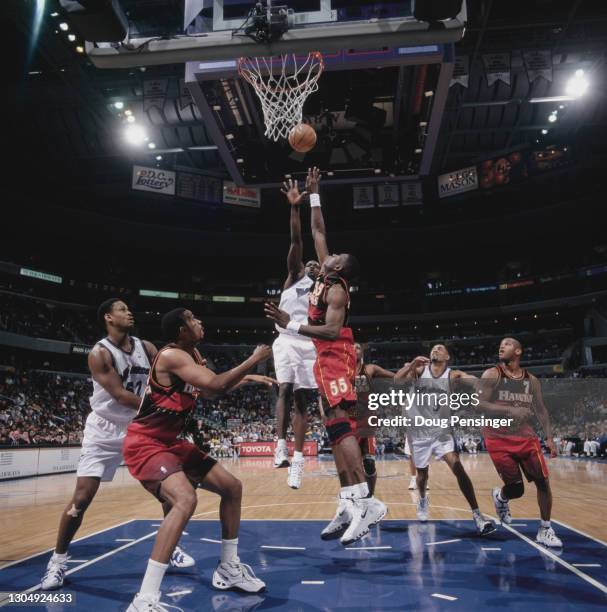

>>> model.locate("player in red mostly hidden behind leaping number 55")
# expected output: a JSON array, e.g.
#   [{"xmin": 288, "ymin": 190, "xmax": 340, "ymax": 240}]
[{"xmin": 350, "ymin": 342, "xmax": 404, "ymax": 495}]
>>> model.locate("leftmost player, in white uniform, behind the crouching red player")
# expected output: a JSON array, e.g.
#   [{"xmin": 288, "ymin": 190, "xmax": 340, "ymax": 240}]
[{"xmin": 41, "ymin": 298, "xmax": 194, "ymax": 590}]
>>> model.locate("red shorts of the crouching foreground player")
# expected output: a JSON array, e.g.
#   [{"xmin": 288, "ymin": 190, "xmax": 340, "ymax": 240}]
[{"xmin": 122, "ymin": 433, "xmax": 217, "ymax": 497}]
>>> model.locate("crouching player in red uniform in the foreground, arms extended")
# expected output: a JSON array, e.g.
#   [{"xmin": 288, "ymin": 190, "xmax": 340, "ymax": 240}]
[{"xmin": 124, "ymin": 308, "xmax": 273, "ymax": 612}]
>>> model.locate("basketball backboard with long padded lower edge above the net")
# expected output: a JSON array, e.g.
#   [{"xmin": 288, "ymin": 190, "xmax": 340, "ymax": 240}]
[{"xmin": 86, "ymin": 0, "xmax": 466, "ymax": 68}]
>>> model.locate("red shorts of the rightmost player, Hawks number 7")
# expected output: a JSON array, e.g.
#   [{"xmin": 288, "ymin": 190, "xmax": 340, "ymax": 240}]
[{"xmin": 485, "ymin": 436, "xmax": 548, "ymax": 484}]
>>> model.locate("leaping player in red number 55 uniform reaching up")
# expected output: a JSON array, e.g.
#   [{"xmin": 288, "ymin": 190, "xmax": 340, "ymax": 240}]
[{"xmin": 265, "ymin": 168, "xmax": 387, "ymax": 546}]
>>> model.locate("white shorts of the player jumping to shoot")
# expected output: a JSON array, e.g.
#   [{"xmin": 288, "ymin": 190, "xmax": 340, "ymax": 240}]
[{"xmin": 272, "ymin": 334, "xmax": 316, "ymax": 389}]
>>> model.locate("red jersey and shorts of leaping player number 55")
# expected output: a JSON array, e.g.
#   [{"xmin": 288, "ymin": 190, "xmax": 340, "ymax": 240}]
[{"xmin": 308, "ymin": 274, "xmax": 356, "ymax": 407}]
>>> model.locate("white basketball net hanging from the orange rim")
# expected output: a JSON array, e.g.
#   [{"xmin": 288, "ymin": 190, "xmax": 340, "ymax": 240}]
[{"xmin": 238, "ymin": 51, "xmax": 325, "ymax": 141}]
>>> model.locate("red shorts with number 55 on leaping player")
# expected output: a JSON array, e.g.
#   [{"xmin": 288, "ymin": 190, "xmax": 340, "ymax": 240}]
[{"xmin": 313, "ymin": 327, "xmax": 356, "ymax": 408}]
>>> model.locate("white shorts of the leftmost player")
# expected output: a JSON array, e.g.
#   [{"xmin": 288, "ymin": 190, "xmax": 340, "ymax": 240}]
[{"xmin": 76, "ymin": 412, "xmax": 128, "ymax": 482}]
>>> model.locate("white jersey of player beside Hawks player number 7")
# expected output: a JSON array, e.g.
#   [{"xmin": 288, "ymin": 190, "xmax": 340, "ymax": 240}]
[{"xmin": 409, "ymin": 366, "xmax": 451, "ymax": 439}]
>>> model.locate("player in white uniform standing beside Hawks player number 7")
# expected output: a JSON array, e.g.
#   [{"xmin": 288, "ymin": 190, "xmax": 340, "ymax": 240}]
[{"xmin": 403, "ymin": 344, "xmax": 495, "ymax": 535}]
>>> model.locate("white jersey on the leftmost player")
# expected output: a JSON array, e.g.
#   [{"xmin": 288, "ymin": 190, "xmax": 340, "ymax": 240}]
[{"xmin": 90, "ymin": 336, "xmax": 151, "ymax": 425}]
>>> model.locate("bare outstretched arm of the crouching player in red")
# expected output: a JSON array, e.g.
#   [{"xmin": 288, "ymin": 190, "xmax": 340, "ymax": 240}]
[{"xmin": 165, "ymin": 345, "xmax": 272, "ymax": 394}]
